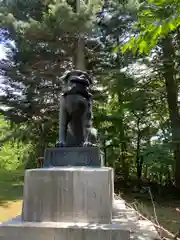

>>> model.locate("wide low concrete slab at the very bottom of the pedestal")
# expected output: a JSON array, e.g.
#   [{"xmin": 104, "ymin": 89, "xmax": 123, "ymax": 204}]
[{"xmin": 0, "ymin": 222, "xmax": 130, "ymax": 240}]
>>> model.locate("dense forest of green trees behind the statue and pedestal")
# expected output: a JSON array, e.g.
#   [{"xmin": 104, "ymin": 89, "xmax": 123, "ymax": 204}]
[{"xmin": 0, "ymin": 0, "xmax": 180, "ymax": 197}]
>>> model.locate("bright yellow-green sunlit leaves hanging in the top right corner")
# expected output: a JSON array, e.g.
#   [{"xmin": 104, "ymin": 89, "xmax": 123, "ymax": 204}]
[{"xmin": 119, "ymin": 0, "xmax": 180, "ymax": 55}]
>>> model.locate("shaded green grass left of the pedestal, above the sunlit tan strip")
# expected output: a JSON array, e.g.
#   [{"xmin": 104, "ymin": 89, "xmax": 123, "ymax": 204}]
[{"xmin": 0, "ymin": 170, "xmax": 24, "ymax": 207}]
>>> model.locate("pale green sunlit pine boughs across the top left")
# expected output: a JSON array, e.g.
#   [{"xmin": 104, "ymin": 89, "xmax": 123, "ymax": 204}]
[{"xmin": 0, "ymin": 0, "xmax": 103, "ymax": 37}]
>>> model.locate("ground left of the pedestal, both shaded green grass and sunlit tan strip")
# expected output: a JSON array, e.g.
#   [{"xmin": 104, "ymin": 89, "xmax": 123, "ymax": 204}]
[{"xmin": 0, "ymin": 170, "xmax": 24, "ymax": 222}]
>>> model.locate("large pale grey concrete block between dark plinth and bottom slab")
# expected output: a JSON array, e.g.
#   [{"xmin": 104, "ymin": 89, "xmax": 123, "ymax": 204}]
[{"xmin": 22, "ymin": 167, "xmax": 114, "ymax": 223}]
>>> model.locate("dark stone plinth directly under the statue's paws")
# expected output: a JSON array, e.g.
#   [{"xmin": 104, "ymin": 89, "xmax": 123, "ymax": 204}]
[{"xmin": 43, "ymin": 147, "xmax": 103, "ymax": 167}]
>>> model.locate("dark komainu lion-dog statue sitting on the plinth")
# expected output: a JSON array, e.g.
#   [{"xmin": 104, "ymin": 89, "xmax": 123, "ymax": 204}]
[{"xmin": 56, "ymin": 70, "xmax": 97, "ymax": 147}]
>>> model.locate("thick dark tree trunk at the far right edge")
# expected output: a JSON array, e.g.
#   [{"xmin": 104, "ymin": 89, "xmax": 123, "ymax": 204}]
[{"xmin": 162, "ymin": 36, "xmax": 180, "ymax": 188}]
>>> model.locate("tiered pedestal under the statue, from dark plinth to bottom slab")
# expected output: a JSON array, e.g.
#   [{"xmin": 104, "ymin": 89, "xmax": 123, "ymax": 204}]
[{"xmin": 0, "ymin": 148, "xmax": 130, "ymax": 240}]
